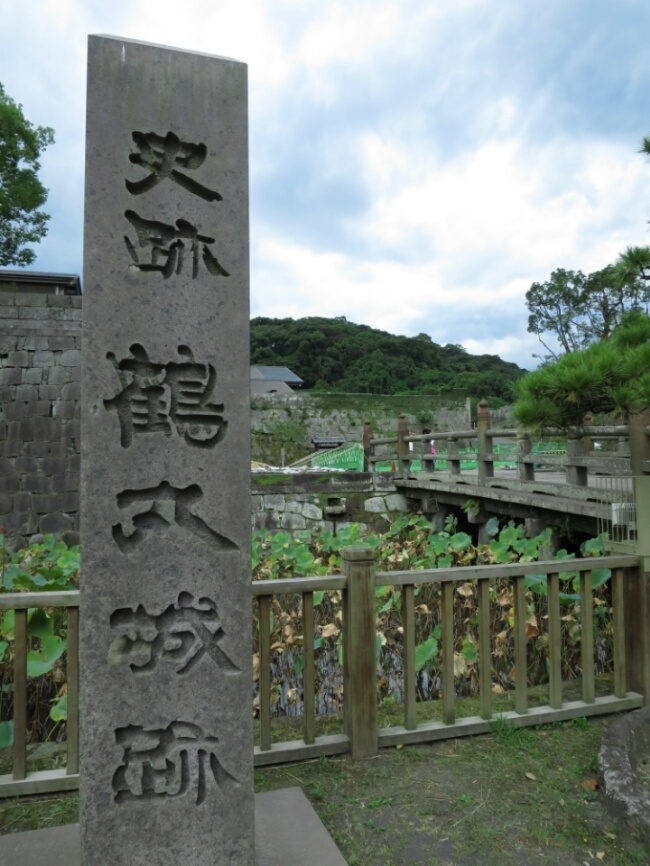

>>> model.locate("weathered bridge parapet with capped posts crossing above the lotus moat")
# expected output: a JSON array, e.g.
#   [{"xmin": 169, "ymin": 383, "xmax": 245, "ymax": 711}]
[{"xmin": 364, "ymin": 401, "xmax": 650, "ymax": 540}]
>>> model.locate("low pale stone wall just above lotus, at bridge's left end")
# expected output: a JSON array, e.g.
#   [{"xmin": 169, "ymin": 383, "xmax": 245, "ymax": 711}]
[{"xmin": 252, "ymin": 472, "xmax": 413, "ymax": 538}]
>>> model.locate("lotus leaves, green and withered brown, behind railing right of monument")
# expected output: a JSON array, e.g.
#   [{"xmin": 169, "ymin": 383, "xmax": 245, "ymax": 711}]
[{"xmin": 254, "ymin": 515, "xmax": 611, "ymax": 714}]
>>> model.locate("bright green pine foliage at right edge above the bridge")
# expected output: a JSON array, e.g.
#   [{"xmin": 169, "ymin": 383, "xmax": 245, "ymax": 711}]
[{"xmin": 514, "ymin": 310, "xmax": 650, "ymax": 430}]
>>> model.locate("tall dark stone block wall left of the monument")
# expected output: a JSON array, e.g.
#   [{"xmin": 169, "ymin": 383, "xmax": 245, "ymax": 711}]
[{"xmin": 0, "ymin": 293, "xmax": 81, "ymax": 540}]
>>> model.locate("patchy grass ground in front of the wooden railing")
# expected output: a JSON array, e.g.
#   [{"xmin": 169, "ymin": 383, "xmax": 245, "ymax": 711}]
[{"xmin": 0, "ymin": 706, "xmax": 650, "ymax": 866}]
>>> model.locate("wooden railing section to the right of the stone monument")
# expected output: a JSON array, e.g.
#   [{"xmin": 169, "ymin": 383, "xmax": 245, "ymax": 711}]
[{"xmin": 253, "ymin": 546, "xmax": 650, "ymax": 766}]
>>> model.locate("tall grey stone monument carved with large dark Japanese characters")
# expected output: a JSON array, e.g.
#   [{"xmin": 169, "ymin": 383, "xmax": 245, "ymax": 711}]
[{"xmin": 80, "ymin": 36, "xmax": 255, "ymax": 866}]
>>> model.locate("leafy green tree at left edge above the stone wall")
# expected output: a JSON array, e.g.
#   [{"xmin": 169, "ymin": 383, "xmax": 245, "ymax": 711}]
[{"xmin": 0, "ymin": 84, "xmax": 54, "ymax": 266}]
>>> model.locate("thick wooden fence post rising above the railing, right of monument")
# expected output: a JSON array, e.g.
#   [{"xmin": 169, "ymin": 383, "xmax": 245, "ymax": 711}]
[{"xmin": 341, "ymin": 544, "xmax": 378, "ymax": 760}]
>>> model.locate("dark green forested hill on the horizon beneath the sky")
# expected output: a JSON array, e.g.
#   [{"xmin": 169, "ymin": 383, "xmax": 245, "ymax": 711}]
[{"xmin": 251, "ymin": 317, "xmax": 526, "ymax": 401}]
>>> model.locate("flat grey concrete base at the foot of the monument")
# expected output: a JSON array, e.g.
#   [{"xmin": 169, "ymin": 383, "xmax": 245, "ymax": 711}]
[{"xmin": 0, "ymin": 788, "xmax": 346, "ymax": 866}]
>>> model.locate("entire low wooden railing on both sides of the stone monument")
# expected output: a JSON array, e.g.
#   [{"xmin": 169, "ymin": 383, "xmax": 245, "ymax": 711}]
[{"xmin": 0, "ymin": 545, "xmax": 650, "ymax": 797}]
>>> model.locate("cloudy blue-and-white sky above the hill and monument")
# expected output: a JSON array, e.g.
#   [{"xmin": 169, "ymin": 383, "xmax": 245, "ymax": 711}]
[{"xmin": 0, "ymin": 0, "xmax": 650, "ymax": 367}]
